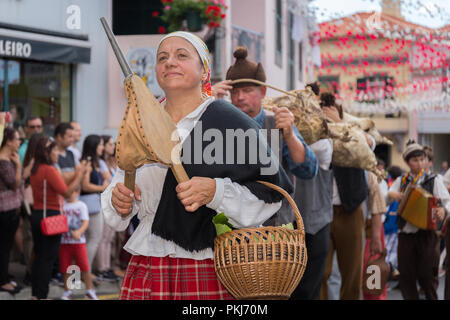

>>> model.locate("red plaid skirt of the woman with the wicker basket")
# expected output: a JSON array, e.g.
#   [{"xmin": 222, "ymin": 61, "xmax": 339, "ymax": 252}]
[{"xmin": 119, "ymin": 256, "xmax": 233, "ymax": 300}]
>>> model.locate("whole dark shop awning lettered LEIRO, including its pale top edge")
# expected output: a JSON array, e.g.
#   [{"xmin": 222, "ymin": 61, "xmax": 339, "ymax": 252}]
[{"xmin": 0, "ymin": 28, "xmax": 91, "ymax": 63}]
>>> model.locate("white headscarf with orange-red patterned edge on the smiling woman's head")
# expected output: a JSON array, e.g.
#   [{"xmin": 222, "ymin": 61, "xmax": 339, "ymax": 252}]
[{"xmin": 157, "ymin": 31, "xmax": 212, "ymax": 97}]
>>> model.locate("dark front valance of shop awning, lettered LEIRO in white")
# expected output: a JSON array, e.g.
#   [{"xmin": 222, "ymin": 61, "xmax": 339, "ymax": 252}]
[{"xmin": 0, "ymin": 35, "xmax": 91, "ymax": 63}]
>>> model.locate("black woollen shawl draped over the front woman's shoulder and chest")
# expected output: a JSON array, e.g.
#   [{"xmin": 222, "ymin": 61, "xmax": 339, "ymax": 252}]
[{"xmin": 152, "ymin": 100, "xmax": 293, "ymax": 251}]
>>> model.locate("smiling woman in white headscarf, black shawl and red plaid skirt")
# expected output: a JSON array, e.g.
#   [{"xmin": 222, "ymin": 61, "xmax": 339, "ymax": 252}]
[{"xmin": 102, "ymin": 31, "xmax": 292, "ymax": 300}]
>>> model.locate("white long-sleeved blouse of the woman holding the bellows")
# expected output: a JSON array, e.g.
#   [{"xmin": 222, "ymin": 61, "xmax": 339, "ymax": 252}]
[{"xmin": 101, "ymin": 98, "xmax": 281, "ymax": 260}]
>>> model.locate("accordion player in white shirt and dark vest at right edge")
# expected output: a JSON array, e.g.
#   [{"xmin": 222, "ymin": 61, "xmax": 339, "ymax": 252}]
[{"xmin": 388, "ymin": 140, "xmax": 450, "ymax": 300}]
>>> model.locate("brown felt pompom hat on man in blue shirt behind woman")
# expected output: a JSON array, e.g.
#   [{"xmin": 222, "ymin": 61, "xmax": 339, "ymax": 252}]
[{"xmin": 226, "ymin": 47, "xmax": 266, "ymax": 88}]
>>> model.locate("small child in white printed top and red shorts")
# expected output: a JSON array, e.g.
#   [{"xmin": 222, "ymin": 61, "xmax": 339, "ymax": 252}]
[{"xmin": 59, "ymin": 188, "xmax": 98, "ymax": 300}]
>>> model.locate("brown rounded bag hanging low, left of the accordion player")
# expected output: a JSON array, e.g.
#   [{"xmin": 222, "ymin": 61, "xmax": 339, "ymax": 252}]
[{"xmin": 363, "ymin": 249, "xmax": 391, "ymax": 296}]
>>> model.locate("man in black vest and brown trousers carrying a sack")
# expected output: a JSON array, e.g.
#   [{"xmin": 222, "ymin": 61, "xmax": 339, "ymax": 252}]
[{"xmin": 320, "ymin": 93, "xmax": 375, "ymax": 300}]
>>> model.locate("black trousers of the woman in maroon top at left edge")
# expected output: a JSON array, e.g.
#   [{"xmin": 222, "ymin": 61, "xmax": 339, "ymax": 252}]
[{"xmin": 0, "ymin": 209, "xmax": 19, "ymax": 286}]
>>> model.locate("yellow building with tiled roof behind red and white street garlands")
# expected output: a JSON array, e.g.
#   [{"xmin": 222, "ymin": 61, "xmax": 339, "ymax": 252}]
[{"xmin": 316, "ymin": 0, "xmax": 448, "ymax": 168}]
